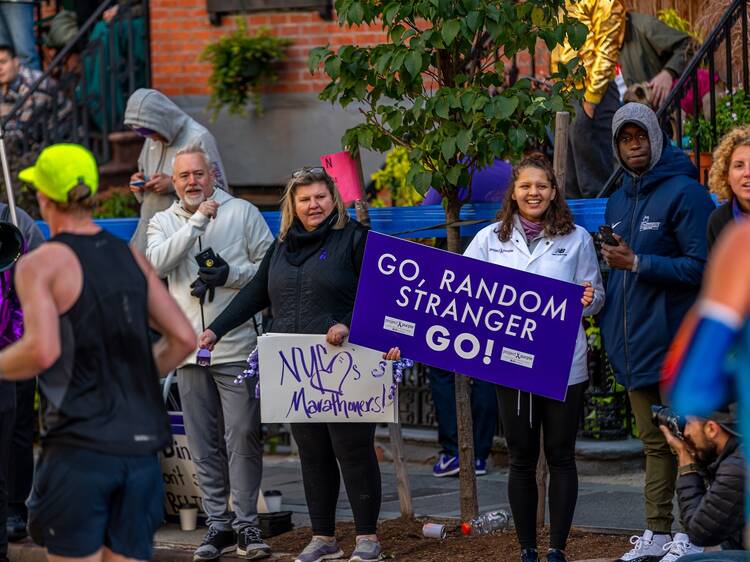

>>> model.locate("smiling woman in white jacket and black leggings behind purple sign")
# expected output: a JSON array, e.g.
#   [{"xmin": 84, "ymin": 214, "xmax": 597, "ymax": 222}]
[{"xmin": 464, "ymin": 155, "xmax": 604, "ymax": 562}]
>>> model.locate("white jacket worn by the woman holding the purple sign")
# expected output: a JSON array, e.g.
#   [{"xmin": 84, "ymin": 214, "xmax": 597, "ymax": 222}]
[{"xmin": 464, "ymin": 218, "xmax": 604, "ymax": 386}]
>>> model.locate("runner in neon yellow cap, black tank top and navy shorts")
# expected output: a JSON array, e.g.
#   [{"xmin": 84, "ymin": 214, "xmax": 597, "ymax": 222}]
[{"xmin": 0, "ymin": 144, "xmax": 195, "ymax": 562}]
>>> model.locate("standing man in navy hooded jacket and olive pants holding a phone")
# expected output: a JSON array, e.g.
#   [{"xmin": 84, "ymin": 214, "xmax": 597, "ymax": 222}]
[{"xmin": 602, "ymin": 103, "xmax": 714, "ymax": 562}]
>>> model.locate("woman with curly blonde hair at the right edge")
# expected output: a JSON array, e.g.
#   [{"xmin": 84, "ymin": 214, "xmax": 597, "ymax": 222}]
[{"xmin": 706, "ymin": 125, "xmax": 750, "ymax": 250}]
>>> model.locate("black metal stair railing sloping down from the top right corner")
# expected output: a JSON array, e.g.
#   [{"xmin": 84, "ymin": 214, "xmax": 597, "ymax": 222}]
[{"xmin": 597, "ymin": 0, "xmax": 750, "ymax": 197}]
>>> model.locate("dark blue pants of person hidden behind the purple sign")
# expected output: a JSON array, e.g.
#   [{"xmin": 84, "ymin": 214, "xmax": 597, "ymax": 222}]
[{"xmin": 429, "ymin": 367, "xmax": 497, "ymax": 459}]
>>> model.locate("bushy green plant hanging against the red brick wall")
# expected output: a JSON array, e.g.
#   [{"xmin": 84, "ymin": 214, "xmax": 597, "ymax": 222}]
[{"xmin": 200, "ymin": 18, "xmax": 292, "ymax": 119}]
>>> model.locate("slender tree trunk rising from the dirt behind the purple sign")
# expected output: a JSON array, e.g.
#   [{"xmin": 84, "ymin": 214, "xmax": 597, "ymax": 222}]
[{"xmin": 445, "ymin": 198, "xmax": 479, "ymax": 521}]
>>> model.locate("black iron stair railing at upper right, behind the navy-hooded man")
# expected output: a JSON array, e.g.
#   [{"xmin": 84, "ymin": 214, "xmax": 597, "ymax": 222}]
[{"xmin": 597, "ymin": 0, "xmax": 750, "ymax": 197}]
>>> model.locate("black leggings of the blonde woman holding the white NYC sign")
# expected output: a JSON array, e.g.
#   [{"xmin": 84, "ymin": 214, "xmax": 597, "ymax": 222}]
[{"xmin": 292, "ymin": 423, "xmax": 381, "ymax": 537}]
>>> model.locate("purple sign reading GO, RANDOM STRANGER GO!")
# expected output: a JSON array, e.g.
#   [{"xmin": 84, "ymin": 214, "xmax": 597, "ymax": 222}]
[{"xmin": 349, "ymin": 232, "xmax": 583, "ymax": 400}]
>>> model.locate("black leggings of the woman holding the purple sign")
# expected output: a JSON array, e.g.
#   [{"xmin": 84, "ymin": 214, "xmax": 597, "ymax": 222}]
[{"xmin": 500, "ymin": 382, "xmax": 588, "ymax": 550}]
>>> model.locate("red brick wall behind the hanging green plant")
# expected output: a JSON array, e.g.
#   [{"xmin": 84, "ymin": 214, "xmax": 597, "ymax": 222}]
[{"xmin": 150, "ymin": 0, "xmax": 548, "ymax": 96}]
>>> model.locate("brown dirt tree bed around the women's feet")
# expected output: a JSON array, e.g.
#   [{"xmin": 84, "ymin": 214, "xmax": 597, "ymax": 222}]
[{"xmin": 266, "ymin": 519, "xmax": 629, "ymax": 562}]
